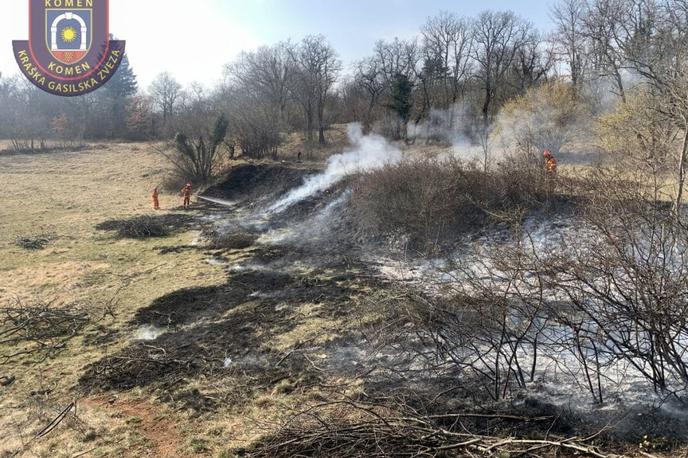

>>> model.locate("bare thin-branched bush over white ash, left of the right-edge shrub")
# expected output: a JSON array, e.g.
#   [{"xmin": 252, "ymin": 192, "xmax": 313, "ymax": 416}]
[{"xmin": 395, "ymin": 236, "xmax": 562, "ymax": 403}]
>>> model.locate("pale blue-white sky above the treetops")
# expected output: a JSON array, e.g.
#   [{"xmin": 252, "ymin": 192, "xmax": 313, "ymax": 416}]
[{"xmin": 0, "ymin": 0, "xmax": 554, "ymax": 89}]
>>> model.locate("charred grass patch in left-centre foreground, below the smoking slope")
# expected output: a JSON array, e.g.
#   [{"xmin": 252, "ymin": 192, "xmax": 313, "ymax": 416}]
[{"xmin": 79, "ymin": 240, "xmax": 382, "ymax": 416}]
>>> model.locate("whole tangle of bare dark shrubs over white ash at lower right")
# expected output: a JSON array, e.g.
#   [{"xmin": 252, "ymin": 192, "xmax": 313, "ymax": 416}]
[{"xmin": 382, "ymin": 167, "xmax": 688, "ymax": 404}]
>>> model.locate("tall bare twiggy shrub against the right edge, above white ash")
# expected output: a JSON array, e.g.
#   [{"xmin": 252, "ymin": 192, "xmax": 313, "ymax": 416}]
[{"xmin": 550, "ymin": 170, "xmax": 688, "ymax": 400}]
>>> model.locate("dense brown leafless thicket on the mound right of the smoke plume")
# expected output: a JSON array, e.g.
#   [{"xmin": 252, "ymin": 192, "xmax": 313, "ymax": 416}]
[{"xmin": 351, "ymin": 159, "xmax": 551, "ymax": 250}]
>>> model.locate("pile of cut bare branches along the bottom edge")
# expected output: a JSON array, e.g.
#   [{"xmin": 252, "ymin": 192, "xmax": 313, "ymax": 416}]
[{"xmin": 247, "ymin": 401, "xmax": 613, "ymax": 458}]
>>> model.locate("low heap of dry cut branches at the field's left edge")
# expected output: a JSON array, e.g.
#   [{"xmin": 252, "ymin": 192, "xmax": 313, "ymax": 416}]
[{"xmin": 0, "ymin": 300, "xmax": 91, "ymax": 364}]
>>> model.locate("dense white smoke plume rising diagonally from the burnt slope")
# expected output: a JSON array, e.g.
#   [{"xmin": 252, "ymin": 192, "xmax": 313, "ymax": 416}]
[{"xmin": 269, "ymin": 123, "xmax": 403, "ymax": 212}]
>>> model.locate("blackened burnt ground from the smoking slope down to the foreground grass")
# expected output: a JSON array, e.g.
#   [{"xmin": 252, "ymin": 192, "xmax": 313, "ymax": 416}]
[{"xmin": 79, "ymin": 164, "xmax": 383, "ymax": 411}]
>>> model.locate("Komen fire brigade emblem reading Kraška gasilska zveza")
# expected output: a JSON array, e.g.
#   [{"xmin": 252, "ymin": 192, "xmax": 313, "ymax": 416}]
[{"xmin": 12, "ymin": 0, "xmax": 125, "ymax": 97}]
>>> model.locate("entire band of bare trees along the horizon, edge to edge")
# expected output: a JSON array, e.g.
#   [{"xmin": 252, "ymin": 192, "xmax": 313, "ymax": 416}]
[{"xmin": 0, "ymin": 0, "xmax": 688, "ymax": 163}]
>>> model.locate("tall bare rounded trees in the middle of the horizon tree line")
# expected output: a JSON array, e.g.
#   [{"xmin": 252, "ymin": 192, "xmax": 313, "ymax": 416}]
[{"xmin": 224, "ymin": 12, "xmax": 555, "ymax": 143}]
